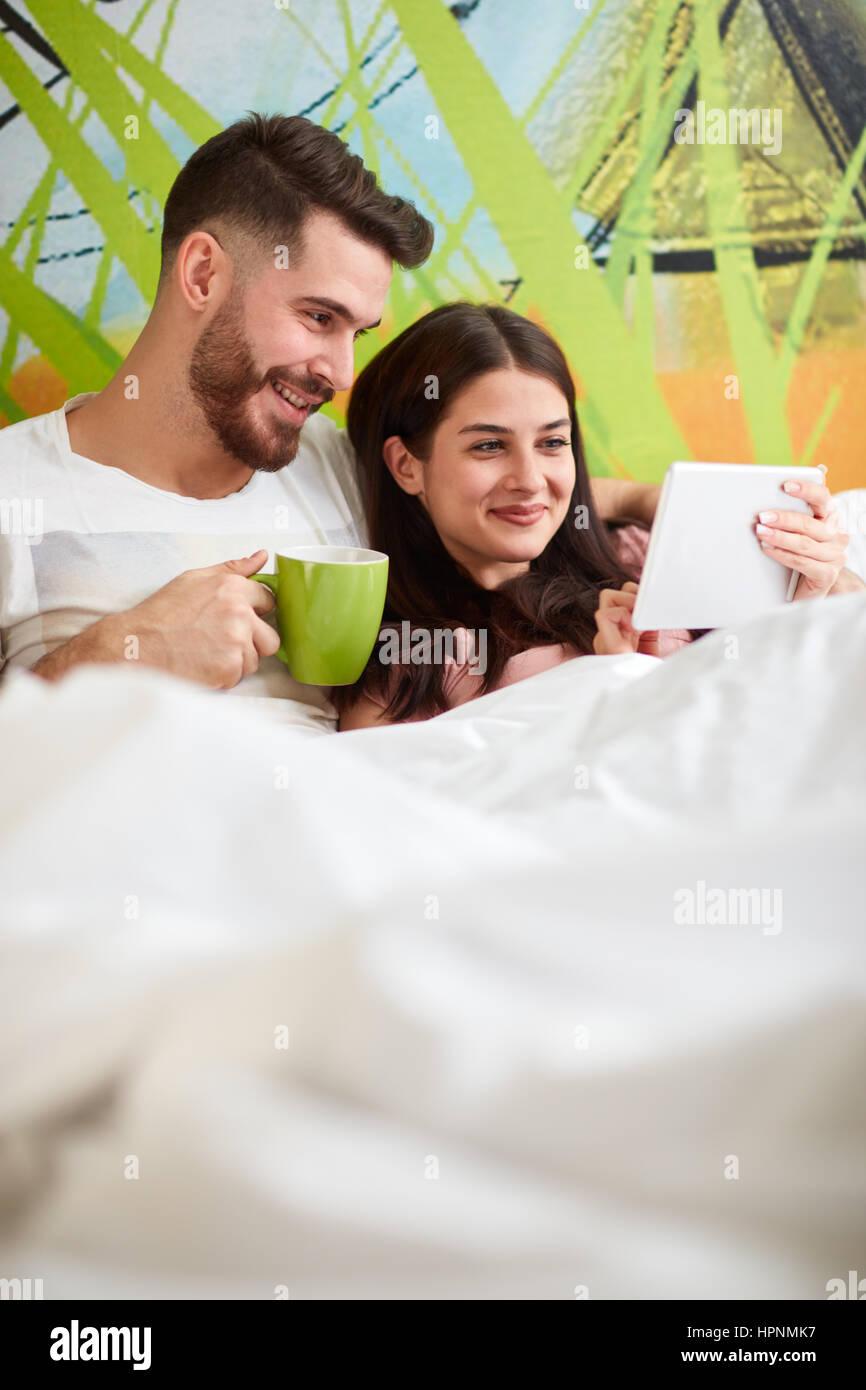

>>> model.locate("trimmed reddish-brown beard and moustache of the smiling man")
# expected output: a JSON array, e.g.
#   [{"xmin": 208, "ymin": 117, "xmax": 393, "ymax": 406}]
[{"xmin": 189, "ymin": 292, "xmax": 332, "ymax": 473}]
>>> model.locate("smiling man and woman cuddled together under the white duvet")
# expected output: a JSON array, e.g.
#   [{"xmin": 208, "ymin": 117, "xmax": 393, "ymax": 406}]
[{"xmin": 0, "ymin": 114, "xmax": 856, "ymax": 730}]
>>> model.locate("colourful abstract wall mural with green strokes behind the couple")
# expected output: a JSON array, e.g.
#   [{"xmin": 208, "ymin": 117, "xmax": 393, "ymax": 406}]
[{"xmin": 0, "ymin": 0, "xmax": 866, "ymax": 489}]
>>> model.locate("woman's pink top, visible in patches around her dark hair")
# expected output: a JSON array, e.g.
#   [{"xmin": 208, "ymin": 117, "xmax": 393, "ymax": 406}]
[{"xmin": 355, "ymin": 525, "xmax": 691, "ymax": 723}]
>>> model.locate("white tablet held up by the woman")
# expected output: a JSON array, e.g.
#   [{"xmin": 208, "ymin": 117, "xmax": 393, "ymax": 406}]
[{"xmin": 632, "ymin": 463, "xmax": 824, "ymax": 632}]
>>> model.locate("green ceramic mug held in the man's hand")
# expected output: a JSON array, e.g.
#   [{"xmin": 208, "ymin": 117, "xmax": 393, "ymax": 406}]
[{"xmin": 252, "ymin": 545, "xmax": 388, "ymax": 685}]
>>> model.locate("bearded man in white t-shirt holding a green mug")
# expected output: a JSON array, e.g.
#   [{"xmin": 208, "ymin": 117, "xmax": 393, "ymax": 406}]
[{"xmin": 0, "ymin": 114, "xmax": 655, "ymax": 728}]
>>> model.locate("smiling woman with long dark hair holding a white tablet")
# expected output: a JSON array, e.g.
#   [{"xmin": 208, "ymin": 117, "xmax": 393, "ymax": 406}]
[{"xmin": 334, "ymin": 303, "xmax": 844, "ymax": 730}]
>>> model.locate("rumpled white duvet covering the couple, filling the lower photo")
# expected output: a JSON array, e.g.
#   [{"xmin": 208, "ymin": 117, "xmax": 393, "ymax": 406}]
[{"xmin": 0, "ymin": 595, "xmax": 866, "ymax": 1300}]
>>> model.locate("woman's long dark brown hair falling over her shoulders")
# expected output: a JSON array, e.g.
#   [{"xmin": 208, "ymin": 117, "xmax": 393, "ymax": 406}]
[{"xmin": 334, "ymin": 303, "xmax": 638, "ymax": 720}]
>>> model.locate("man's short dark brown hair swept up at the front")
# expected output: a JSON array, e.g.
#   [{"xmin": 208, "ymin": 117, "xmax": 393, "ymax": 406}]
[{"xmin": 160, "ymin": 111, "xmax": 434, "ymax": 284}]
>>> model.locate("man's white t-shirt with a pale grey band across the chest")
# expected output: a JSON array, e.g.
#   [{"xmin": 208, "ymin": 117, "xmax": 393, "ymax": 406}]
[{"xmin": 0, "ymin": 392, "xmax": 367, "ymax": 728}]
